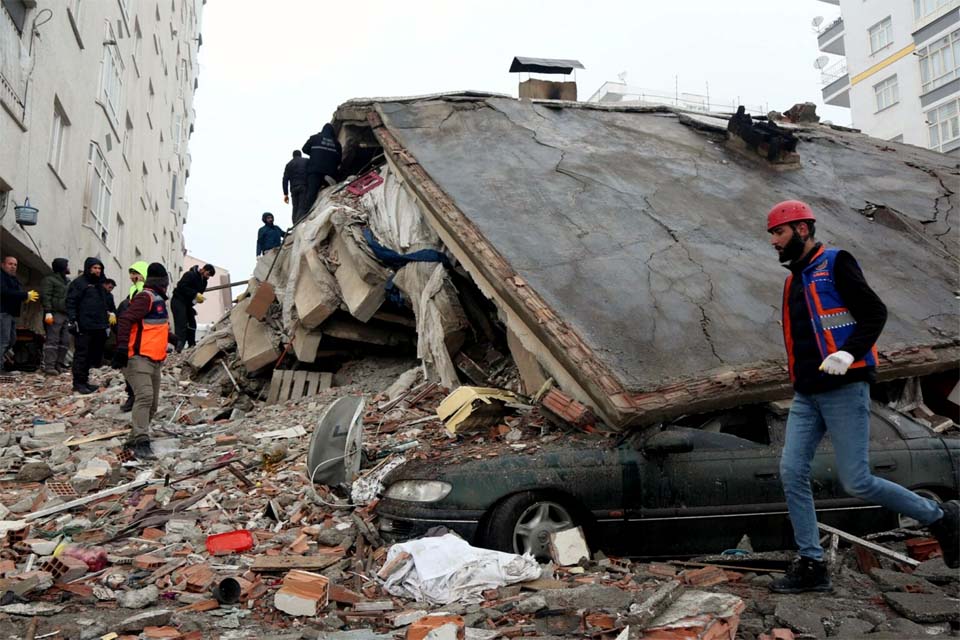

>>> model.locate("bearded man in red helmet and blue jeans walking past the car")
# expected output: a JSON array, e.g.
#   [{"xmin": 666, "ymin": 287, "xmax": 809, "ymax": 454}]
[{"xmin": 767, "ymin": 200, "xmax": 960, "ymax": 593}]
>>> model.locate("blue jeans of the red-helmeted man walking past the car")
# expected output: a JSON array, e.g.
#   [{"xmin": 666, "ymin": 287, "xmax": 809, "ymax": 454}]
[{"xmin": 780, "ymin": 382, "xmax": 943, "ymax": 560}]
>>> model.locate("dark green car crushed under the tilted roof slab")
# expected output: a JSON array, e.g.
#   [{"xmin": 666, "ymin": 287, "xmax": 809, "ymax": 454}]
[{"xmin": 377, "ymin": 403, "xmax": 960, "ymax": 557}]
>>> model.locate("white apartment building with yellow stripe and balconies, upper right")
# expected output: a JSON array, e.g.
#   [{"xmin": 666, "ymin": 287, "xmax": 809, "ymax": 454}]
[{"xmin": 817, "ymin": 0, "xmax": 960, "ymax": 155}]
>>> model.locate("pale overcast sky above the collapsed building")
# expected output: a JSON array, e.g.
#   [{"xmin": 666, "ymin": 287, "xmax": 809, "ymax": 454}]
[{"xmin": 184, "ymin": 0, "xmax": 849, "ymax": 280}]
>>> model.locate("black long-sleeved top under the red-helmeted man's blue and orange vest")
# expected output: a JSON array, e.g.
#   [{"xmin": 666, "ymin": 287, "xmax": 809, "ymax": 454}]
[{"xmin": 787, "ymin": 244, "xmax": 887, "ymax": 394}]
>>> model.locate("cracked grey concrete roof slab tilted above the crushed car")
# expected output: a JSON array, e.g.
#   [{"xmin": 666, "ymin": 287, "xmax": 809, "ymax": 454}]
[{"xmin": 379, "ymin": 98, "xmax": 960, "ymax": 390}]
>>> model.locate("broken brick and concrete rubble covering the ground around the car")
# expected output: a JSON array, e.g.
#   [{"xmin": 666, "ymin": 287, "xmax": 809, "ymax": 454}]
[{"xmin": 0, "ymin": 354, "xmax": 958, "ymax": 640}]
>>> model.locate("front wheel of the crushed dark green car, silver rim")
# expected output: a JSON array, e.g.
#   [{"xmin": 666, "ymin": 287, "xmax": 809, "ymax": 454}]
[{"xmin": 484, "ymin": 491, "xmax": 577, "ymax": 560}]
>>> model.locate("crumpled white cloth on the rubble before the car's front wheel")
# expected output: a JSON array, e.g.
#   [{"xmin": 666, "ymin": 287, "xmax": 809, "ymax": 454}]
[{"xmin": 383, "ymin": 533, "xmax": 540, "ymax": 605}]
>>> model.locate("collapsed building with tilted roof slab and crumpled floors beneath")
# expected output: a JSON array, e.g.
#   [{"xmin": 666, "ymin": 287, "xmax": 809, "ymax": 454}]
[{"xmin": 192, "ymin": 92, "xmax": 960, "ymax": 428}]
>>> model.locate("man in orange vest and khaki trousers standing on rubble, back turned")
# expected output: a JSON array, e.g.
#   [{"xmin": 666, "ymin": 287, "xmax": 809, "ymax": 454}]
[{"xmin": 111, "ymin": 262, "xmax": 174, "ymax": 460}]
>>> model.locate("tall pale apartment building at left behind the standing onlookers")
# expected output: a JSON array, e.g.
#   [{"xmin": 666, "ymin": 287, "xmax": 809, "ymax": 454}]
[{"xmin": 0, "ymin": 0, "xmax": 205, "ymax": 296}]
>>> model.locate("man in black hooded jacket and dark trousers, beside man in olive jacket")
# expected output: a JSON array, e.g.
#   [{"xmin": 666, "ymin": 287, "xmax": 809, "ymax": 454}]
[{"xmin": 67, "ymin": 258, "xmax": 117, "ymax": 394}]
